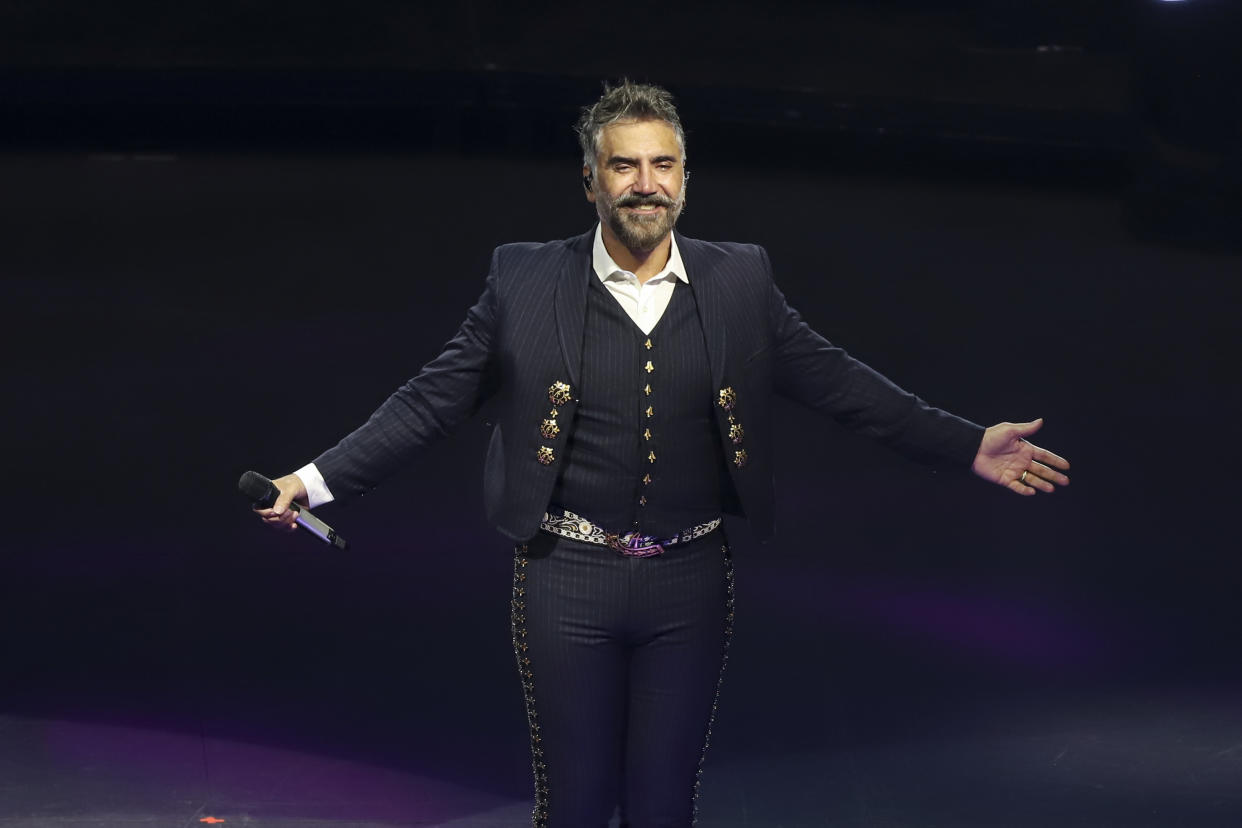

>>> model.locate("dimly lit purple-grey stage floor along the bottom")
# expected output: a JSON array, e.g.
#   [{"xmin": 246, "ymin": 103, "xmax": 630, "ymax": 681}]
[{"xmin": 0, "ymin": 689, "xmax": 1242, "ymax": 828}]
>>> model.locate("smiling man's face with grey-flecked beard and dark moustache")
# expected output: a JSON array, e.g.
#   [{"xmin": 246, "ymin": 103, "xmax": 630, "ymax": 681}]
[{"xmin": 582, "ymin": 120, "xmax": 686, "ymax": 252}]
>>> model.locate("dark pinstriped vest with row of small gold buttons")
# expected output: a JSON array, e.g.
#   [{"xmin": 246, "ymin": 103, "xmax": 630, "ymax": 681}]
[{"xmin": 551, "ymin": 276, "xmax": 725, "ymax": 538}]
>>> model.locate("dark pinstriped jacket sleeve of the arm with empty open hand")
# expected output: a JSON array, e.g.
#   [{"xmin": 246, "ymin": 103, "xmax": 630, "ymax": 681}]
[{"xmin": 763, "ymin": 245, "xmax": 984, "ymax": 467}]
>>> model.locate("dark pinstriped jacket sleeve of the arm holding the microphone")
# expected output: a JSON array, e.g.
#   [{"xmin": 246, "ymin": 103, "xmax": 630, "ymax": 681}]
[{"xmin": 314, "ymin": 250, "xmax": 499, "ymax": 500}]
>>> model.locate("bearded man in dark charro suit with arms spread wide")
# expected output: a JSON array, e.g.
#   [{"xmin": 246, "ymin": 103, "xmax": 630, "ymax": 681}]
[{"xmin": 252, "ymin": 82, "xmax": 1068, "ymax": 828}]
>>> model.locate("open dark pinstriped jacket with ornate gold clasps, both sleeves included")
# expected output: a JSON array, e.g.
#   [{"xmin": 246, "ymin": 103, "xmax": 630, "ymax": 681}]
[{"xmin": 315, "ymin": 231, "xmax": 982, "ymax": 540}]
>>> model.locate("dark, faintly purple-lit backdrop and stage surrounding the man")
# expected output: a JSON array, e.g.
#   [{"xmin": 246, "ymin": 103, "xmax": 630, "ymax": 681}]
[{"xmin": 0, "ymin": 0, "xmax": 1242, "ymax": 826}]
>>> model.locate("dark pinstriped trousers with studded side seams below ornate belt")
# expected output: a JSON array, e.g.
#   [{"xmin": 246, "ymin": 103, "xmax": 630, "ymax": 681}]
[{"xmin": 513, "ymin": 531, "xmax": 733, "ymax": 828}]
